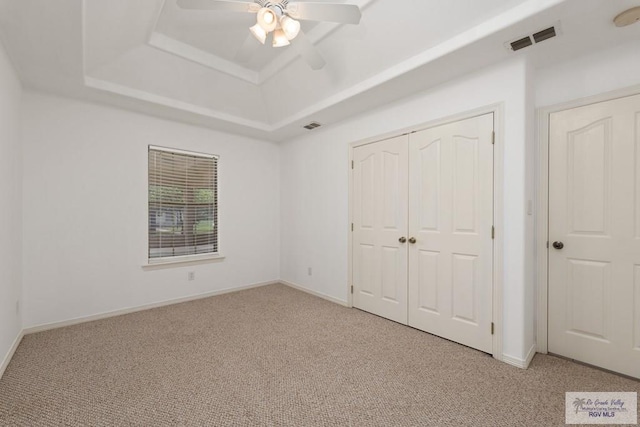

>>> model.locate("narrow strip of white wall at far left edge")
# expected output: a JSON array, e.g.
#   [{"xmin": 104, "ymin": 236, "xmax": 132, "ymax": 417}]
[{"xmin": 0, "ymin": 43, "xmax": 22, "ymax": 375}]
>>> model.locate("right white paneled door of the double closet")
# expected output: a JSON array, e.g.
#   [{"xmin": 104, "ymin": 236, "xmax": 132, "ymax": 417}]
[{"xmin": 409, "ymin": 114, "xmax": 493, "ymax": 353}]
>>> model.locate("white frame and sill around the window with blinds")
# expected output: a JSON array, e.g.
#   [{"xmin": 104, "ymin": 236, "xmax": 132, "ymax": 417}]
[{"xmin": 143, "ymin": 144, "xmax": 224, "ymax": 267}]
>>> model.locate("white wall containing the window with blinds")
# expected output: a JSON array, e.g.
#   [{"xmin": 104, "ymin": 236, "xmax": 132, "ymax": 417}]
[{"xmin": 21, "ymin": 93, "xmax": 280, "ymax": 327}]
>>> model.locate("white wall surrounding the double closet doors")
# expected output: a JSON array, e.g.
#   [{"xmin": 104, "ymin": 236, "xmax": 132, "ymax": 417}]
[{"xmin": 280, "ymin": 57, "xmax": 534, "ymax": 360}]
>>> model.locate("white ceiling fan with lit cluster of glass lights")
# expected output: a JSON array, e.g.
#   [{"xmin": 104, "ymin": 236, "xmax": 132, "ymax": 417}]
[{"xmin": 177, "ymin": 0, "xmax": 362, "ymax": 70}]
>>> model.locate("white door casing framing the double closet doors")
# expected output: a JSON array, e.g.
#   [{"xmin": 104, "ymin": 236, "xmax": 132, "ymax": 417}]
[{"xmin": 347, "ymin": 103, "xmax": 504, "ymax": 362}]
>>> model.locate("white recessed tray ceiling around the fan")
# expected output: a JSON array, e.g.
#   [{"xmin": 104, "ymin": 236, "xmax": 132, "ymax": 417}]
[{"xmin": 0, "ymin": 0, "xmax": 640, "ymax": 140}]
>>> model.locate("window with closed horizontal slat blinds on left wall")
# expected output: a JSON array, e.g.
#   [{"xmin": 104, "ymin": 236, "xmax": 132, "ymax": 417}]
[{"xmin": 149, "ymin": 146, "xmax": 218, "ymax": 263}]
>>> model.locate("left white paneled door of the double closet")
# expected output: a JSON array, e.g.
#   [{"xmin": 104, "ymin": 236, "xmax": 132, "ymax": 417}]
[{"xmin": 353, "ymin": 136, "xmax": 408, "ymax": 324}]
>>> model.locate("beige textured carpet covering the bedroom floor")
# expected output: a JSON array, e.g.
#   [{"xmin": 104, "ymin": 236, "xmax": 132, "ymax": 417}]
[{"xmin": 0, "ymin": 285, "xmax": 640, "ymax": 427}]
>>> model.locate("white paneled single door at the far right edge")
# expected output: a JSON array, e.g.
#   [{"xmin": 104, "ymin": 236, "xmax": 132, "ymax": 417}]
[{"xmin": 548, "ymin": 96, "xmax": 640, "ymax": 378}]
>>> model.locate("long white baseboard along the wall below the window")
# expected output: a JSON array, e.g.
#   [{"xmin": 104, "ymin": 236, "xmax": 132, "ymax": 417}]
[{"xmin": 23, "ymin": 280, "xmax": 281, "ymax": 335}]
